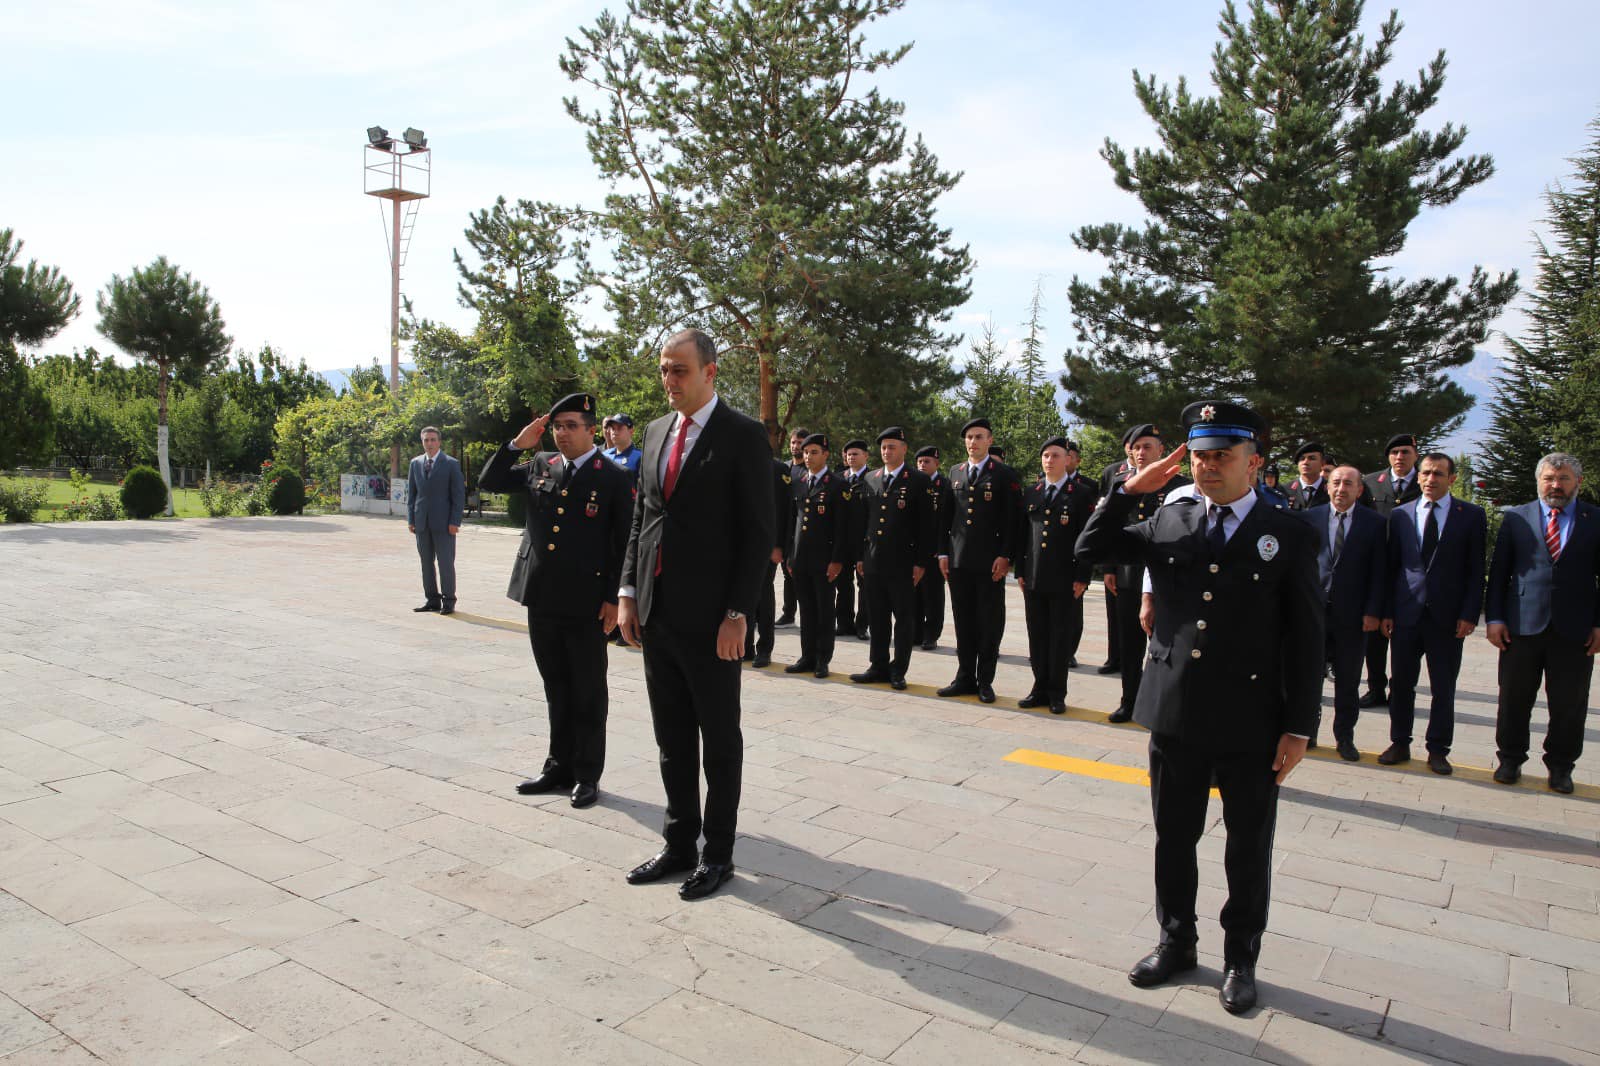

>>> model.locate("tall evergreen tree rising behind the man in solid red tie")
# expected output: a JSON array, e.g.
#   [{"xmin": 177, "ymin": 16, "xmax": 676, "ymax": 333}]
[{"xmin": 562, "ymin": 0, "xmax": 971, "ymax": 447}]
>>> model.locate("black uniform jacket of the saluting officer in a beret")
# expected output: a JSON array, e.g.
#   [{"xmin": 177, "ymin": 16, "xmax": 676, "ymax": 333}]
[{"xmin": 478, "ymin": 445, "xmax": 635, "ymax": 618}]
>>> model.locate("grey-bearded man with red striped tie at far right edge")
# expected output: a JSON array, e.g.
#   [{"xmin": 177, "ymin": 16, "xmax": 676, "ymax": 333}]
[{"xmin": 1488, "ymin": 451, "xmax": 1600, "ymax": 794}]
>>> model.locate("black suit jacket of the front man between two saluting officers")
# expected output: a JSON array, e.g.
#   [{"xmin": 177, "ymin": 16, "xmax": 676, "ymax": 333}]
[{"xmin": 621, "ymin": 397, "xmax": 778, "ymax": 632}]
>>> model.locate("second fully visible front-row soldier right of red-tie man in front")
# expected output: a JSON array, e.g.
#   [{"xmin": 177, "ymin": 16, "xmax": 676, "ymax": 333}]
[{"xmin": 850, "ymin": 426, "xmax": 939, "ymax": 690}]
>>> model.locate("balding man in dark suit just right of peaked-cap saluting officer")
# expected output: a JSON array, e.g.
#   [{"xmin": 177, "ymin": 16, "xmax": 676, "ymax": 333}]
[{"xmin": 1296, "ymin": 466, "xmax": 1387, "ymax": 762}]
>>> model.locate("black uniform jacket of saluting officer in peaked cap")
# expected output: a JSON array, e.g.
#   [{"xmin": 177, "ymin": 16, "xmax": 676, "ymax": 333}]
[{"xmin": 1078, "ymin": 493, "xmax": 1325, "ymax": 751}]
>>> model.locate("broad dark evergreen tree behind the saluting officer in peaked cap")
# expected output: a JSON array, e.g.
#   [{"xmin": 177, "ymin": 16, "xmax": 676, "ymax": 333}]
[{"xmin": 1062, "ymin": 0, "xmax": 1517, "ymax": 464}]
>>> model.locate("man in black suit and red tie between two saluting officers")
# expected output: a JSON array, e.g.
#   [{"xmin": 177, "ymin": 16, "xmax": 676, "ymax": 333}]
[{"xmin": 618, "ymin": 330, "xmax": 778, "ymax": 900}]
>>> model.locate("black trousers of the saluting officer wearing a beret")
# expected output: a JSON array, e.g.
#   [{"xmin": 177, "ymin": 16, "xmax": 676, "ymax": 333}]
[{"xmin": 528, "ymin": 607, "xmax": 610, "ymax": 784}]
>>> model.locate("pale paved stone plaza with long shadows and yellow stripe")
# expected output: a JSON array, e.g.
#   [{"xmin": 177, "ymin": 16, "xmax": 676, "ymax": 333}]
[{"xmin": 0, "ymin": 515, "xmax": 1600, "ymax": 1066}]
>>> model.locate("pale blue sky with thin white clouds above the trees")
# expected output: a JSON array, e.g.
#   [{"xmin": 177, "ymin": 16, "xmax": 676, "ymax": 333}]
[{"xmin": 0, "ymin": 0, "xmax": 1600, "ymax": 444}]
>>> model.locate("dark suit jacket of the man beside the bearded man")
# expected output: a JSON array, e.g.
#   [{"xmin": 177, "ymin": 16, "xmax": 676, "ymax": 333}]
[{"xmin": 1384, "ymin": 496, "xmax": 1488, "ymax": 627}]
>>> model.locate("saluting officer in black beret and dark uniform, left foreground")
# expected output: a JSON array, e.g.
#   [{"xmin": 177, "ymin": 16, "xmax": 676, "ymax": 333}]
[{"xmin": 478, "ymin": 392, "xmax": 634, "ymax": 807}]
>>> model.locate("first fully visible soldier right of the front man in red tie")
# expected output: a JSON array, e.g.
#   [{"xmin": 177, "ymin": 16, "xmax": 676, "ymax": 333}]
[{"xmin": 784, "ymin": 434, "xmax": 854, "ymax": 677}]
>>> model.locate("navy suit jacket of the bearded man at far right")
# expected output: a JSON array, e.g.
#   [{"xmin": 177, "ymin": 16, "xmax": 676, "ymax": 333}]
[{"xmin": 1486, "ymin": 501, "xmax": 1600, "ymax": 642}]
